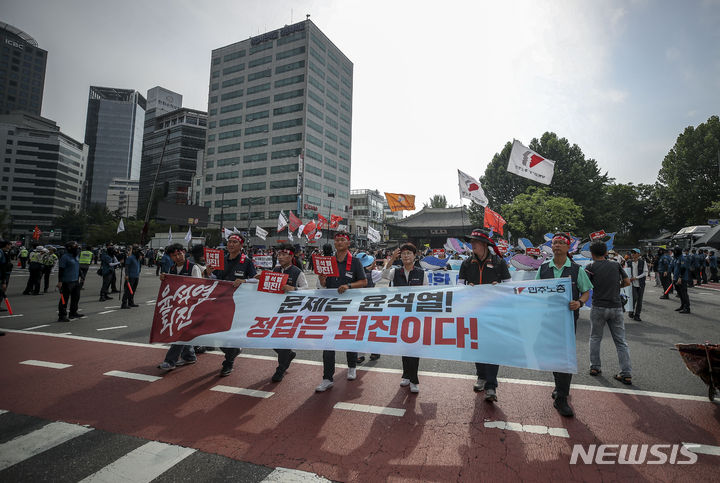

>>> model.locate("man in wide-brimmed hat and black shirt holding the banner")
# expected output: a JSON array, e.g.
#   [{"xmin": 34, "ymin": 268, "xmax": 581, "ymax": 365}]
[{"xmin": 458, "ymin": 228, "xmax": 511, "ymax": 402}]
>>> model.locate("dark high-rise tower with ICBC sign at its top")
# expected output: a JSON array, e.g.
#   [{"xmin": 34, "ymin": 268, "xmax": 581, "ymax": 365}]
[{"xmin": 0, "ymin": 22, "xmax": 47, "ymax": 116}]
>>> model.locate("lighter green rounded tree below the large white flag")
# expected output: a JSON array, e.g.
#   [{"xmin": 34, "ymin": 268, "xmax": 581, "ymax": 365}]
[{"xmin": 501, "ymin": 186, "xmax": 583, "ymax": 243}]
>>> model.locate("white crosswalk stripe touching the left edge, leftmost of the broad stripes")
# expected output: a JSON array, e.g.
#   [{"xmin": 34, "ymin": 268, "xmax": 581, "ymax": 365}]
[{"xmin": 0, "ymin": 422, "xmax": 92, "ymax": 470}]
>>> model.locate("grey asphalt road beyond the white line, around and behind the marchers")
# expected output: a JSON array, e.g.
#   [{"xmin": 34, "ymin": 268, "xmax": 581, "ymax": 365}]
[{"xmin": 0, "ymin": 266, "xmax": 720, "ymax": 400}]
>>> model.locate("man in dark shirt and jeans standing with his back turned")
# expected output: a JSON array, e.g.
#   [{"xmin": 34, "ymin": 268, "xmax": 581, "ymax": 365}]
[{"xmin": 585, "ymin": 241, "xmax": 632, "ymax": 384}]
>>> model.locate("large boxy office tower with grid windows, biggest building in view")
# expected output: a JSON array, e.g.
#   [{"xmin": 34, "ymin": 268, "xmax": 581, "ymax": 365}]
[{"xmin": 200, "ymin": 20, "xmax": 353, "ymax": 240}]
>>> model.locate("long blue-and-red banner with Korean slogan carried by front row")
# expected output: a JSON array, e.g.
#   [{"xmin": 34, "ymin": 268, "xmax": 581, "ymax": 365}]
[{"xmin": 150, "ymin": 276, "xmax": 577, "ymax": 373}]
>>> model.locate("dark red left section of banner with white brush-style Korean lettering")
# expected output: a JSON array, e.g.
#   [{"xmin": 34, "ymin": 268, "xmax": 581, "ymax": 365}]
[{"xmin": 150, "ymin": 275, "xmax": 235, "ymax": 343}]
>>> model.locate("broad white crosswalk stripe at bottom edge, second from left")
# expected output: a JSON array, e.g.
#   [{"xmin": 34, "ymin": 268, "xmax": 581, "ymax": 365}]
[{"xmin": 82, "ymin": 441, "xmax": 195, "ymax": 483}]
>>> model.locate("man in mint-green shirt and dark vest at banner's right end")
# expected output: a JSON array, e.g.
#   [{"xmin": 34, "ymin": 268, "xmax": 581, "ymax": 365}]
[{"xmin": 535, "ymin": 233, "xmax": 593, "ymax": 417}]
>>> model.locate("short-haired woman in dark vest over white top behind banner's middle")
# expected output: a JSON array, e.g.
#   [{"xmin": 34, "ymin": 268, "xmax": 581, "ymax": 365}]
[{"xmin": 382, "ymin": 243, "xmax": 428, "ymax": 393}]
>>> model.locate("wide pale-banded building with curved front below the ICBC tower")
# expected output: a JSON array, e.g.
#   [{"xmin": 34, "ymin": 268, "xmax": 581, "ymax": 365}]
[{"xmin": 0, "ymin": 113, "xmax": 88, "ymax": 239}]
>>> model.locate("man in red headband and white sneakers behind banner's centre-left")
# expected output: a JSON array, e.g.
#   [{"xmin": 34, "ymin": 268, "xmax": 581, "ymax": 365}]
[{"xmin": 315, "ymin": 231, "xmax": 367, "ymax": 392}]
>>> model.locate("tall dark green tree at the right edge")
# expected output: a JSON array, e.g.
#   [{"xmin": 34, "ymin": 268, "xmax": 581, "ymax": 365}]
[{"xmin": 658, "ymin": 116, "xmax": 720, "ymax": 228}]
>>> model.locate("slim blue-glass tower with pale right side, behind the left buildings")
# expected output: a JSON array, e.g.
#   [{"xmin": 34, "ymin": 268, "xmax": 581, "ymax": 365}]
[{"xmin": 85, "ymin": 86, "xmax": 146, "ymax": 205}]
